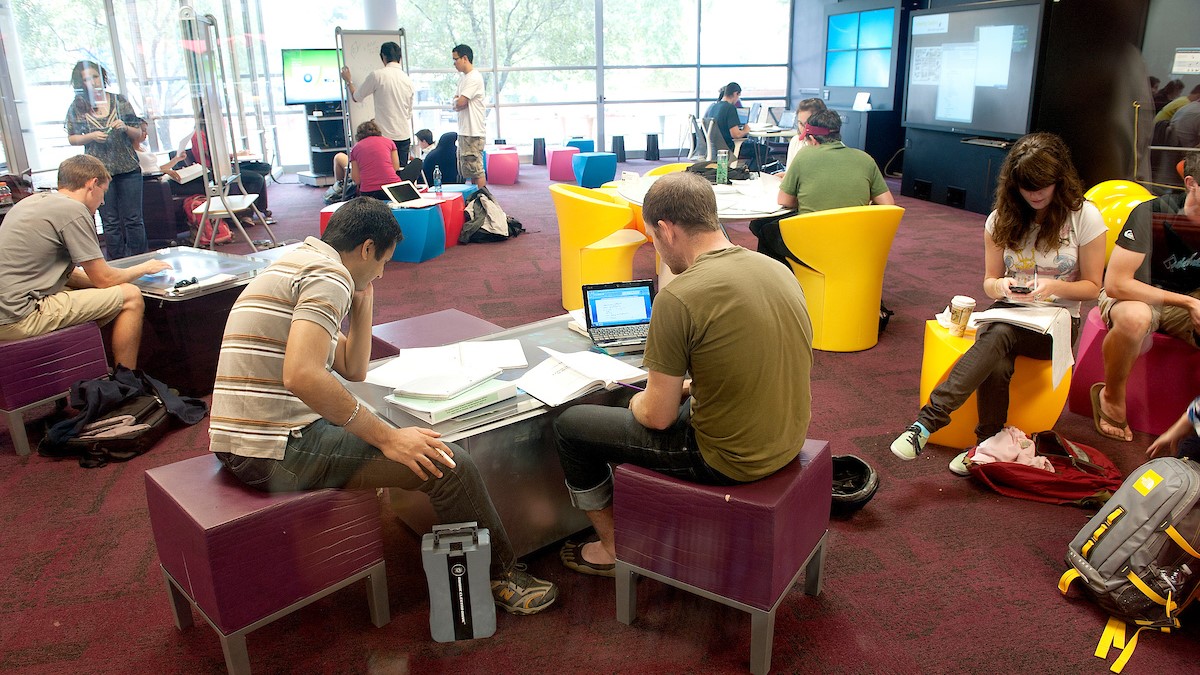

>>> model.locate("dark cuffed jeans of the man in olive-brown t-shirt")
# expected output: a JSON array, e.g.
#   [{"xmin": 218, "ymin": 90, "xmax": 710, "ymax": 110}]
[{"xmin": 554, "ymin": 400, "xmax": 738, "ymax": 510}]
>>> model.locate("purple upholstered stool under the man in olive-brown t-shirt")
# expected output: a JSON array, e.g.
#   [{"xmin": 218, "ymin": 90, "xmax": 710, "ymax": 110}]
[{"xmin": 613, "ymin": 440, "xmax": 833, "ymax": 673}]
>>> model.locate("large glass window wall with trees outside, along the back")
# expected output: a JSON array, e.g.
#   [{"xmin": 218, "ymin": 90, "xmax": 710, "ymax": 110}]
[{"xmin": 0, "ymin": 0, "xmax": 792, "ymax": 171}]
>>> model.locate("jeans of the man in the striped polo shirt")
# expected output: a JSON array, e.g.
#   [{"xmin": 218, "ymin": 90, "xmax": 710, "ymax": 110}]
[{"xmin": 217, "ymin": 419, "xmax": 516, "ymax": 579}]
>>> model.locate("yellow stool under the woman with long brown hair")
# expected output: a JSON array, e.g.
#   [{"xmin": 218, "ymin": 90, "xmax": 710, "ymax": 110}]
[{"xmin": 920, "ymin": 321, "xmax": 1072, "ymax": 448}]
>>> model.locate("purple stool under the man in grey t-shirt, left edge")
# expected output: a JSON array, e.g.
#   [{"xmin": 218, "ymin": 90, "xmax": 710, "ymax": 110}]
[{"xmin": 0, "ymin": 322, "xmax": 108, "ymax": 455}]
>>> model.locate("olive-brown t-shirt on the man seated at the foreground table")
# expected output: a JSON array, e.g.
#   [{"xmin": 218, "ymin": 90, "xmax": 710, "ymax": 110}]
[{"xmin": 644, "ymin": 246, "xmax": 812, "ymax": 482}]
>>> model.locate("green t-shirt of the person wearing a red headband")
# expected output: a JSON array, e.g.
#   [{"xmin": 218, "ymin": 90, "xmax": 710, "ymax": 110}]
[{"xmin": 779, "ymin": 141, "xmax": 888, "ymax": 214}]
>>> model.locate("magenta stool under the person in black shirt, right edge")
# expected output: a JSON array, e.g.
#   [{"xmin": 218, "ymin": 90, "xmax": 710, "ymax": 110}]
[{"xmin": 1067, "ymin": 307, "xmax": 1200, "ymax": 435}]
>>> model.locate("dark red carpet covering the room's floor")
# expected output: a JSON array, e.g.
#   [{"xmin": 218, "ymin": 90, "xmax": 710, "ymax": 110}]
[{"xmin": 0, "ymin": 161, "xmax": 1200, "ymax": 675}]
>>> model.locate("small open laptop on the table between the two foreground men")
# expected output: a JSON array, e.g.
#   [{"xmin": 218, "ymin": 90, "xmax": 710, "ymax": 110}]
[{"xmin": 583, "ymin": 279, "xmax": 654, "ymax": 352}]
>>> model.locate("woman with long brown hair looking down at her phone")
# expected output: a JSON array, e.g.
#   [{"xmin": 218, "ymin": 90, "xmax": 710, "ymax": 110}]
[{"xmin": 892, "ymin": 133, "xmax": 1106, "ymax": 476}]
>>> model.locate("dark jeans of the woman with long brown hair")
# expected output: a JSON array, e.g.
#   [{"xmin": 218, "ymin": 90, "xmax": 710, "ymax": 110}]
[{"xmin": 917, "ymin": 301, "xmax": 1079, "ymax": 443}]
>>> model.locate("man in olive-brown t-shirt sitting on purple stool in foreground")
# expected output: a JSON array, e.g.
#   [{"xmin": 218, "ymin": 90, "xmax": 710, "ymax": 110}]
[{"xmin": 554, "ymin": 172, "xmax": 812, "ymax": 577}]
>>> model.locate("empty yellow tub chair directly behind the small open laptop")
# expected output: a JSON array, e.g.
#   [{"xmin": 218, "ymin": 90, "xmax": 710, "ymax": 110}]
[{"xmin": 550, "ymin": 183, "xmax": 646, "ymax": 310}]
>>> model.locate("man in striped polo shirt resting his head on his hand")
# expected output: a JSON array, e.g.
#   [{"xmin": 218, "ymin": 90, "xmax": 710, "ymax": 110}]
[{"xmin": 209, "ymin": 197, "xmax": 558, "ymax": 614}]
